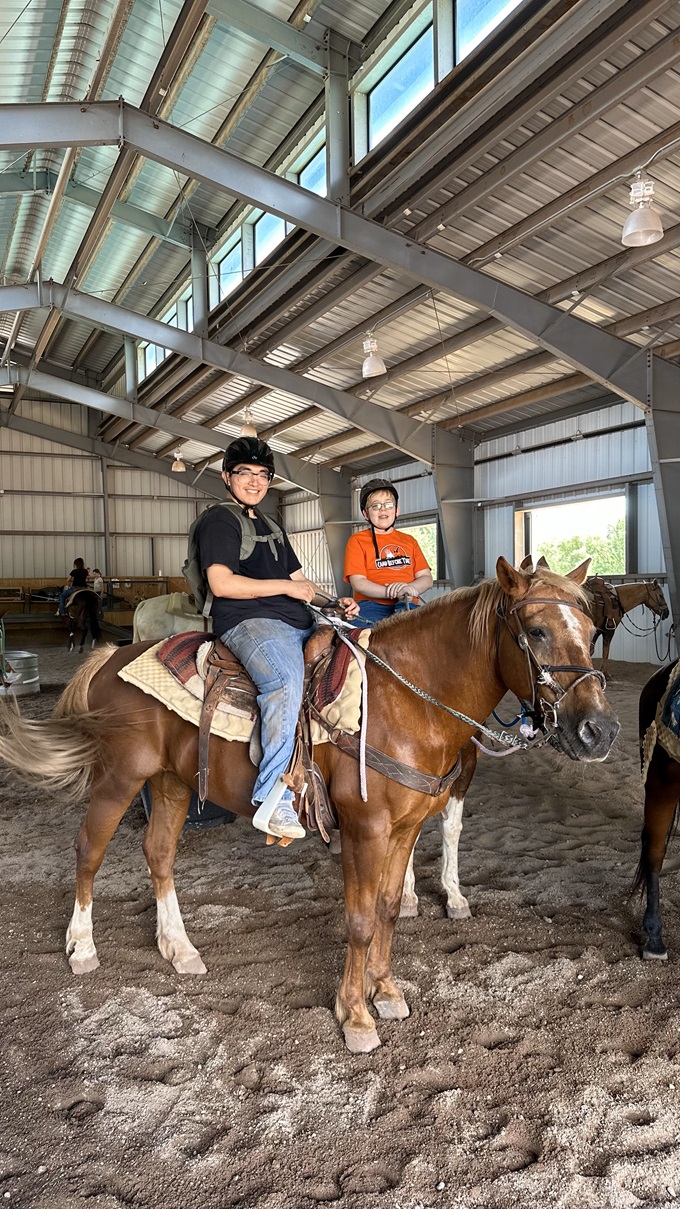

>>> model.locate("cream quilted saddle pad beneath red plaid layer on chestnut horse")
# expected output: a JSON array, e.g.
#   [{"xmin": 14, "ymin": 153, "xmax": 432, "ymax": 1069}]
[{"xmin": 119, "ymin": 630, "xmax": 370, "ymax": 746}]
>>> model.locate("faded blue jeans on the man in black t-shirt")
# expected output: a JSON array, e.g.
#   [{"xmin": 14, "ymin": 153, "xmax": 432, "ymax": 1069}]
[{"xmin": 220, "ymin": 618, "xmax": 315, "ymax": 805}]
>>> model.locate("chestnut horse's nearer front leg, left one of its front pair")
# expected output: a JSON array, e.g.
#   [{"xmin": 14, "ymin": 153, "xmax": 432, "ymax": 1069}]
[{"xmin": 335, "ymin": 817, "xmax": 389, "ymax": 1053}]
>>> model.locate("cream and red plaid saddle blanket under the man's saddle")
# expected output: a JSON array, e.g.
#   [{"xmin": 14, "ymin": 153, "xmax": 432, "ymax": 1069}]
[{"xmin": 119, "ymin": 630, "xmax": 370, "ymax": 744}]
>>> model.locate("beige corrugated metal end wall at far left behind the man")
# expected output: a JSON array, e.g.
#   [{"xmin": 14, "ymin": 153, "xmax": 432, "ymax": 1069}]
[{"xmin": 0, "ymin": 403, "xmax": 209, "ymax": 579}]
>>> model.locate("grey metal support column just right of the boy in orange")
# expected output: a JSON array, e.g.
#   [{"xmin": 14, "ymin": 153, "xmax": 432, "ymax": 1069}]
[{"xmin": 431, "ymin": 424, "xmax": 474, "ymax": 588}]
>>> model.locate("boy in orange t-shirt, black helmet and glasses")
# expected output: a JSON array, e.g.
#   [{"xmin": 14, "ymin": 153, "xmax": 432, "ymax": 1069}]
[{"xmin": 345, "ymin": 479, "xmax": 432, "ymax": 625}]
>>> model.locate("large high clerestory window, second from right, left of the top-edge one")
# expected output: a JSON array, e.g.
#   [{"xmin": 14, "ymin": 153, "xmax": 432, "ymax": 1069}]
[{"xmin": 368, "ymin": 25, "xmax": 434, "ymax": 150}]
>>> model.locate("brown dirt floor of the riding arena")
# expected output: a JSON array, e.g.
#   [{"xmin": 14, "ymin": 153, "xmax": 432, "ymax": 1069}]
[{"xmin": 0, "ymin": 649, "xmax": 680, "ymax": 1209}]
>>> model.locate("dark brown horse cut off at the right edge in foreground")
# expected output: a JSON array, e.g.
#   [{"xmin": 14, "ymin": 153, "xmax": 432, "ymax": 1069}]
[{"xmin": 634, "ymin": 666, "xmax": 680, "ymax": 961}]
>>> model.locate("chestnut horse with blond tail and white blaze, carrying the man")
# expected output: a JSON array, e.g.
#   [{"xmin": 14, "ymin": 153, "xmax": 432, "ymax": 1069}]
[{"xmin": 0, "ymin": 559, "xmax": 618, "ymax": 1052}]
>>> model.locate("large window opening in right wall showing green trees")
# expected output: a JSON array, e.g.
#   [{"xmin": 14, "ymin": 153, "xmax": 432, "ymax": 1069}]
[{"xmin": 515, "ymin": 494, "xmax": 626, "ymax": 575}]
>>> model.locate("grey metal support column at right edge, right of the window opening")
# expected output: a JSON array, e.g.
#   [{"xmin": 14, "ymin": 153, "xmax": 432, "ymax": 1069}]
[{"xmin": 646, "ymin": 351, "xmax": 680, "ymax": 621}]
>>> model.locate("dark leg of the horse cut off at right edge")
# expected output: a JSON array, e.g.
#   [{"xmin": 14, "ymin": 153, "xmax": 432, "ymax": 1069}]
[{"xmin": 636, "ymin": 744, "xmax": 680, "ymax": 961}]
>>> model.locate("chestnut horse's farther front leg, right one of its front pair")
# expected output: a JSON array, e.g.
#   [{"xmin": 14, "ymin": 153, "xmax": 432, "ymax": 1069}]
[{"xmin": 365, "ymin": 817, "xmax": 422, "ymax": 1020}]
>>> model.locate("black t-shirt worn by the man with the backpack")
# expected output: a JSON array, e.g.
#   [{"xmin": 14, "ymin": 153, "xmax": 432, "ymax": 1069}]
[{"xmin": 198, "ymin": 508, "xmax": 312, "ymax": 634}]
